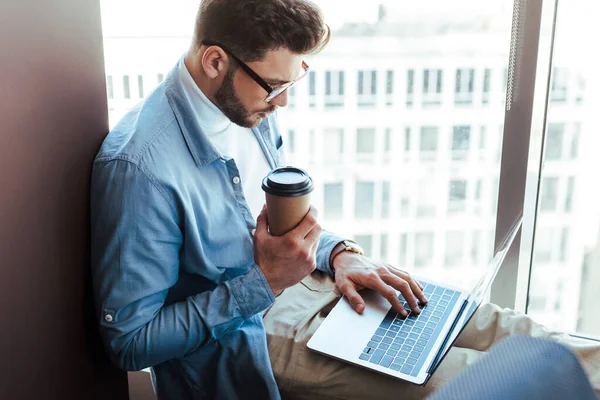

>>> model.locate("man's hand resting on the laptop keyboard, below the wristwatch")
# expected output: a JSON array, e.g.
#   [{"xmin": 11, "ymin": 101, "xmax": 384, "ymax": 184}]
[{"xmin": 333, "ymin": 251, "xmax": 427, "ymax": 316}]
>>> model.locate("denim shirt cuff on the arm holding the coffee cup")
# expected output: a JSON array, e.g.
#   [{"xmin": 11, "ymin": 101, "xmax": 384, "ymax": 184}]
[{"xmin": 231, "ymin": 264, "xmax": 275, "ymax": 319}]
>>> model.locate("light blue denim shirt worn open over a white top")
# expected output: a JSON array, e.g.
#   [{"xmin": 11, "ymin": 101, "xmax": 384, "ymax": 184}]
[{"xmin": 91, "ymin": 60, "xmax": 341, "ymax": 400}]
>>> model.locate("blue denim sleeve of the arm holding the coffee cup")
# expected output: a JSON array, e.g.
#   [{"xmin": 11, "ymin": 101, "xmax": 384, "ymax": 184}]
[{"xmin": 91, "ymin": 160, "xmax": 275, "ymax": 371}]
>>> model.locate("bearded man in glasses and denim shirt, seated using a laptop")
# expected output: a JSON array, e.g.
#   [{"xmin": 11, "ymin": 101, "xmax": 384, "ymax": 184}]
[{"xmin": 91, "ymin": 0, "xmax": 596, "ymax": 400}]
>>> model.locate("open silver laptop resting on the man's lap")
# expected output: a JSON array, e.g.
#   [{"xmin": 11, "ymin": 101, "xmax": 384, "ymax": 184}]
[{"xmin": 308, "ymin": 214, "xmax": 523, "ymax": 385}]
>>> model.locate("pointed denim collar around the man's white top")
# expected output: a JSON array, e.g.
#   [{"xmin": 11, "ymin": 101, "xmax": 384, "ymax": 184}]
[{"xmin": 165, "ymin": 60, "xmax": 275, "ymax": 167}]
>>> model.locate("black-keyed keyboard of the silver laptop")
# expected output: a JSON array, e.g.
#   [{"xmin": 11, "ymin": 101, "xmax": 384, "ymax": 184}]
[{"xmin": 359, "ymin": 283, "xmax": 460, "ymax": 376}]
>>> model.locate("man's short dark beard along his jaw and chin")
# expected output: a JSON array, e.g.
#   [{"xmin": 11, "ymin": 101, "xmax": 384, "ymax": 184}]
[{"xmin": 215, "ymin": 69, "xmax": 276, "ymax": 128}]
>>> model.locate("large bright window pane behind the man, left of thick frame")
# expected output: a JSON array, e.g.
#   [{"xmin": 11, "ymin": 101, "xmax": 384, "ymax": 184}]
[{"xmin": 101, "ymin": 0, "xmax": 512, "ymax": 292}]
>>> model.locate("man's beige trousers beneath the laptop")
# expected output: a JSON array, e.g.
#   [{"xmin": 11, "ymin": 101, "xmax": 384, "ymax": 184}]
[{"xmin": 264, "ymin": 272, "xmax": 600, "ymax": 400}]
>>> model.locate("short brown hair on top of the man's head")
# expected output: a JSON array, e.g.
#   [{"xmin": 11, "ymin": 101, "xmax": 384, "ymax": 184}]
[{"xmin": 192, "ymin": 0, "xmax": 331, "ymax": 62}]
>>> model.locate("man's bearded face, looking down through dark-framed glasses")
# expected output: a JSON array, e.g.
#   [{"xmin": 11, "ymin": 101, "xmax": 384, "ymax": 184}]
[{"xmin": 215, "ymin": 50, "xmax": 302, "ymax": 128}]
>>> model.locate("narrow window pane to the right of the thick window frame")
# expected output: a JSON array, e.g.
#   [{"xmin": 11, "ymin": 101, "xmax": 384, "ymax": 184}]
[{"xmin": 527, "ymin": 0, "xmax": 600, "ymax": 337}]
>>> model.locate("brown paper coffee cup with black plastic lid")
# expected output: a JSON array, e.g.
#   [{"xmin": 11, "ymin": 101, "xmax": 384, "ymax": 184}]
[{"xmin": 262, "ymin": 167, "xmax": 314, "ymax": 236}]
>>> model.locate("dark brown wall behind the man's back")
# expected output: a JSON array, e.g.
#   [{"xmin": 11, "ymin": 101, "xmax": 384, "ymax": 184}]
[{"xmin": 0, "ymin": 0, "xmax": 127, "ymax": 400}]
